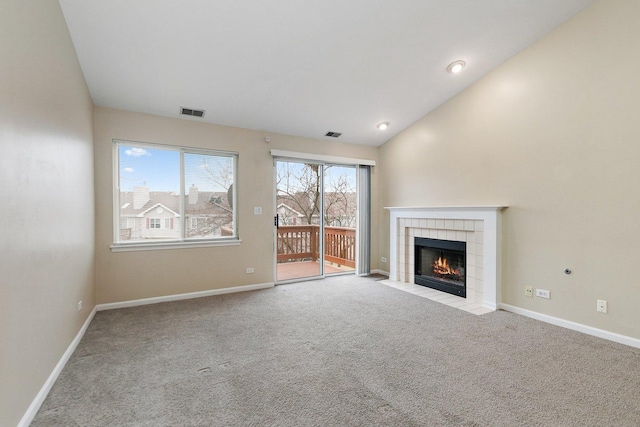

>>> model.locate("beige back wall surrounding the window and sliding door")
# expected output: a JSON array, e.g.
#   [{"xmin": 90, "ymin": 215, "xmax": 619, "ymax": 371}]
[{"xmin": 94, "ymin": 108, "xmax": 378, "ymax": 303}]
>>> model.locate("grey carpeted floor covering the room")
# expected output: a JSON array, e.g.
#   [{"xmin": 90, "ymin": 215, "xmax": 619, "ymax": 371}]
[{"xmin": 32, "ymin": 276, "xmax": 640, "ymax": 426}]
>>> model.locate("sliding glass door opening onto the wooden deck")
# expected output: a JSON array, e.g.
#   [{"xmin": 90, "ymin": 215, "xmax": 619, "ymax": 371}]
[{"xmin": 275, "ymin": 159, "xmax": 358, "ymax": 282}]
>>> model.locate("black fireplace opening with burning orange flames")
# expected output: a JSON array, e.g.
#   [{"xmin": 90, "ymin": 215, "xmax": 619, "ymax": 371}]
[{"xmin": 414, "ymin": 237, "xmax": 467, "ymax": 298}]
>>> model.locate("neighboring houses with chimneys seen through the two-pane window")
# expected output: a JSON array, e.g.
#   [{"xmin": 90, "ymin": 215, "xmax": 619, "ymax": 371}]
[{"xmin": 120, "ymin": 185, "xmax": 233, "ymax": 241}]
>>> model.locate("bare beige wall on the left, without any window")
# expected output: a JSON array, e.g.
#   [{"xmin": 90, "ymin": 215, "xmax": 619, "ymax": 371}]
[{"xmin": 0, "ymin": 0, "xmax": 95, "ymax": 426}]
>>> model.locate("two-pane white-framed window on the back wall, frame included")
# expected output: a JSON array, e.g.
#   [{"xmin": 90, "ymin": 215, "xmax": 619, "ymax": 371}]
[{"xmin": 113, "ymin": 141, "xmax": 238, "ymax": 248}]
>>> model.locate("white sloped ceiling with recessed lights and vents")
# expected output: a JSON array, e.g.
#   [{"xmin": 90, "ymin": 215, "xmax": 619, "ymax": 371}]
[{"xmin": 60, "ymin": 0, "xmax": 593, "ymax": 146}]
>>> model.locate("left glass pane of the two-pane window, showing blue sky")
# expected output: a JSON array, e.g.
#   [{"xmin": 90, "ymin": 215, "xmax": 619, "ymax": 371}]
[{"xmin": 118, "ymin": 145, "xmax": 180, "ymax": 242}]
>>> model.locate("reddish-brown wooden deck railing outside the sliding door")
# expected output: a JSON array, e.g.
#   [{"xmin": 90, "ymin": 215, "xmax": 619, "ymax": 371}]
[{"xmin": 277, "ymin": 225, "xmax": 356, "ymax": 268}]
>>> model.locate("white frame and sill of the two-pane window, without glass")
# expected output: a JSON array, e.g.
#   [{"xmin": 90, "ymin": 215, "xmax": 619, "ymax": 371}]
[{"xmin": 111, "ymin": 139, "xmax": 242, "ymax": 252}]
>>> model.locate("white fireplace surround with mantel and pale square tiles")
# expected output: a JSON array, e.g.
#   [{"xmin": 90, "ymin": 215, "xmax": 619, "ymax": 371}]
[{"xmin": 386, "ymin": 206, "xmax": 505, "ymax": 314}]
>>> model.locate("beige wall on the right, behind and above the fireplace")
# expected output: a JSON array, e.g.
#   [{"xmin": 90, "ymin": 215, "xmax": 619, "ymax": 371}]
[{"xmin": 378, "ymin": 0, "xmax": 640, "ymax": 338}]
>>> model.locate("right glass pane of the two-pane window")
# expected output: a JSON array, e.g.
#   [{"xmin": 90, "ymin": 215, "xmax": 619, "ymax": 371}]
[{"xmin": 184, "ymin": 153, "xmax": 234, "ymax": 239}]
